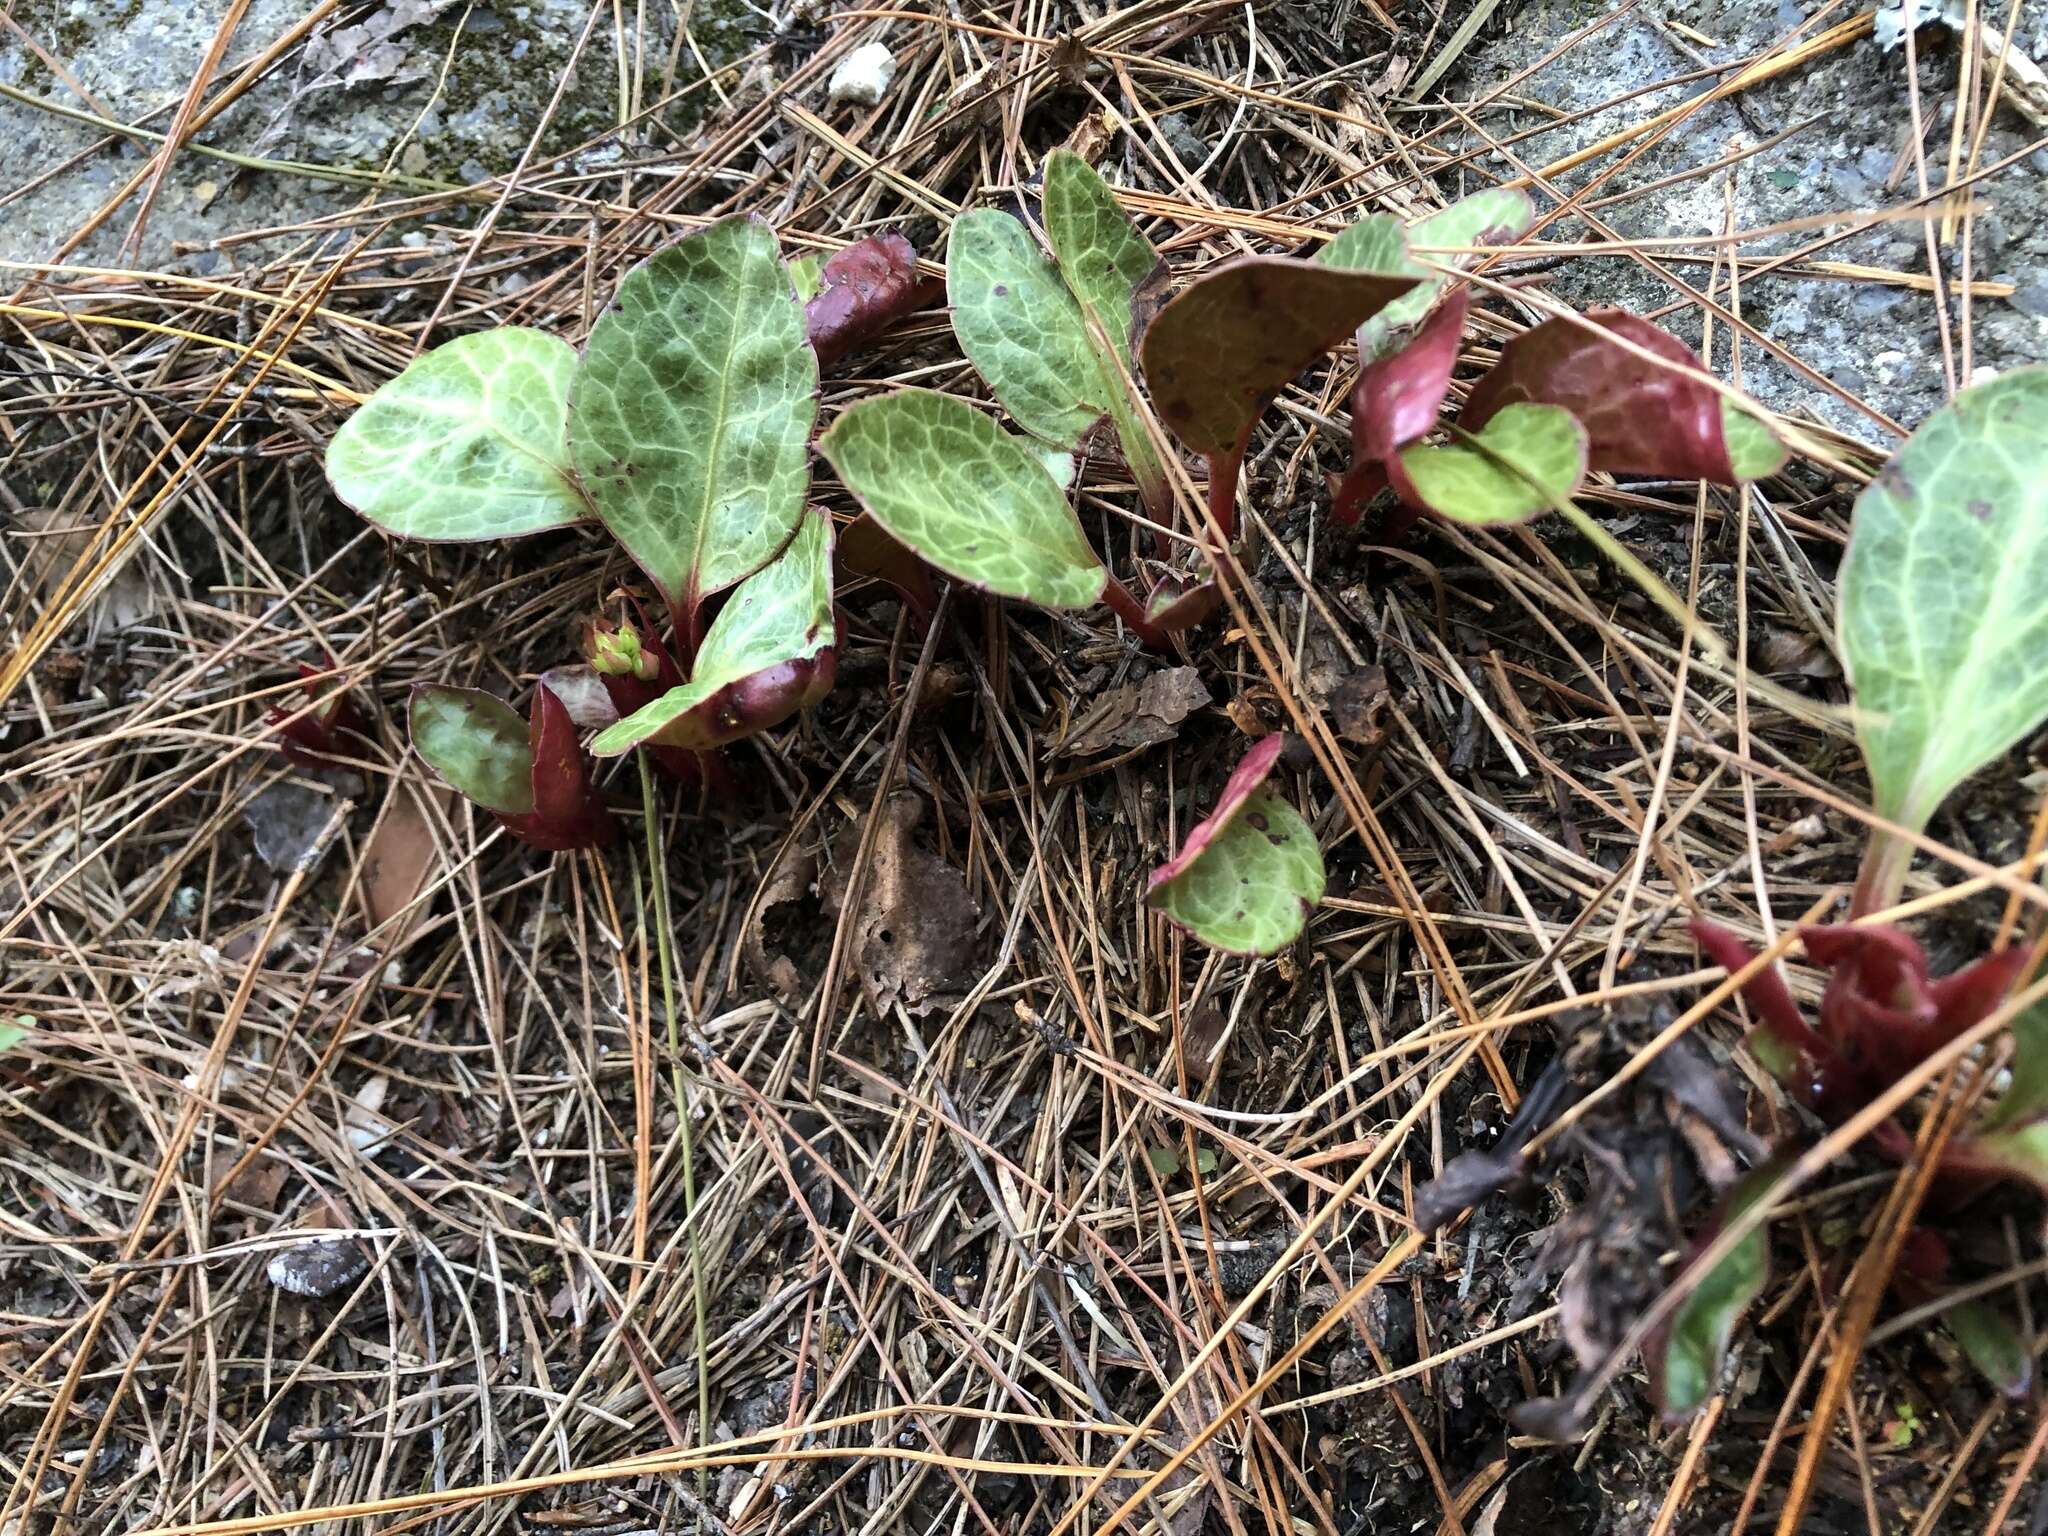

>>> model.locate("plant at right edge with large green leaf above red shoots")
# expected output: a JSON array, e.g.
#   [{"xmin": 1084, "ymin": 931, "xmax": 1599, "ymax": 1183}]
[{"xmin": 1662, "ymin": 369, "xmax": 2048, "ymax": 1417}]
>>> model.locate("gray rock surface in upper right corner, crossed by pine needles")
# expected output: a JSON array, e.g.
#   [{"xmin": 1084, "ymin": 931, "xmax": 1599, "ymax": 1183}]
[{"xmin": 1454, "ymin": 0, "xmax": 2048, "ymax": 446}]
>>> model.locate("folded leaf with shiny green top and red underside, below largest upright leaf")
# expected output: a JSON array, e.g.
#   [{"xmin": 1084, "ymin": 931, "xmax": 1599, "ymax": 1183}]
[{"xmin": 590, "ymin": 510, "xmax": 838, "ymax": 758}]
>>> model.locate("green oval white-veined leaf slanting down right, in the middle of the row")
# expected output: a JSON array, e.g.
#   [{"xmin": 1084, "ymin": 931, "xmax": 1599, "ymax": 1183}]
[{"xmin": 817, "ymin": 389, "xmax": 1108, "ymax": 608}]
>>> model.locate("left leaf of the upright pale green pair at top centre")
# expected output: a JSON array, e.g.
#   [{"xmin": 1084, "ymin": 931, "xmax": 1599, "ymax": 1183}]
[{"xmin": 946, "ymin": 209, "xmax": 1110, "ymax": 449}]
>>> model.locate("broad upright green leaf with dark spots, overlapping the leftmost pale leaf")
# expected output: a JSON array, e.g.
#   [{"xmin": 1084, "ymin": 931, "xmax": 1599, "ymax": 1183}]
[{"xmin": 569, "ymin": 217, "xmax": 817, "ymax": 610}]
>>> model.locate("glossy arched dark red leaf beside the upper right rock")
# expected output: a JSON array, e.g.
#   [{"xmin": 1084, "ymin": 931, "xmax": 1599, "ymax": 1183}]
[{"xmin": 1458, "ymin": 309, "xmax": 1735, "ymax": 485}]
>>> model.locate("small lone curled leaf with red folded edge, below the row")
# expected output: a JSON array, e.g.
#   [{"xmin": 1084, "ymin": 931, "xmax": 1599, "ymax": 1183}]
[{"xmin": 1145, "ymin": 735, "xmax": 1323, "ymax": 954}]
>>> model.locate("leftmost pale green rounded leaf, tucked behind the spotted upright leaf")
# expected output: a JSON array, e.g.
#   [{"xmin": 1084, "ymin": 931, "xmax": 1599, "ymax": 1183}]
[{"xmin": 326, "ymin": 326, "xmax": 590, "ymax": 541}]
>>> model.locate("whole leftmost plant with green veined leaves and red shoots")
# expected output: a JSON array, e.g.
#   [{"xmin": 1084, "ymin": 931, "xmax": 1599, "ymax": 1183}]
[{"xmin": 328, "ymin": 217, "xmax": 864, "ymax": 848}]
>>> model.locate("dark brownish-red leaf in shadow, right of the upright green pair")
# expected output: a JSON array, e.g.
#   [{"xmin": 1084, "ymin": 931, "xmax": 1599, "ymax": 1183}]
[{"xmin": 1141, "ymin": 256, "xmax": 1417, "ymax": 459}]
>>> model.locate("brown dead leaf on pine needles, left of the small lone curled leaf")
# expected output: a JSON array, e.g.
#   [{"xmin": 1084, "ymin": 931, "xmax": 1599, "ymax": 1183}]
[{"xmin": 825, "ymin": 795, "xmax": 981, "ymax": 1014}]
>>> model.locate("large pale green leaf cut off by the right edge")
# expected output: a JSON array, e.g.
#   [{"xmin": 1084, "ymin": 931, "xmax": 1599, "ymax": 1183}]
[{"xmin": 1837, "ymin": 367, "xmax": 2048, "ymax": 831}]
